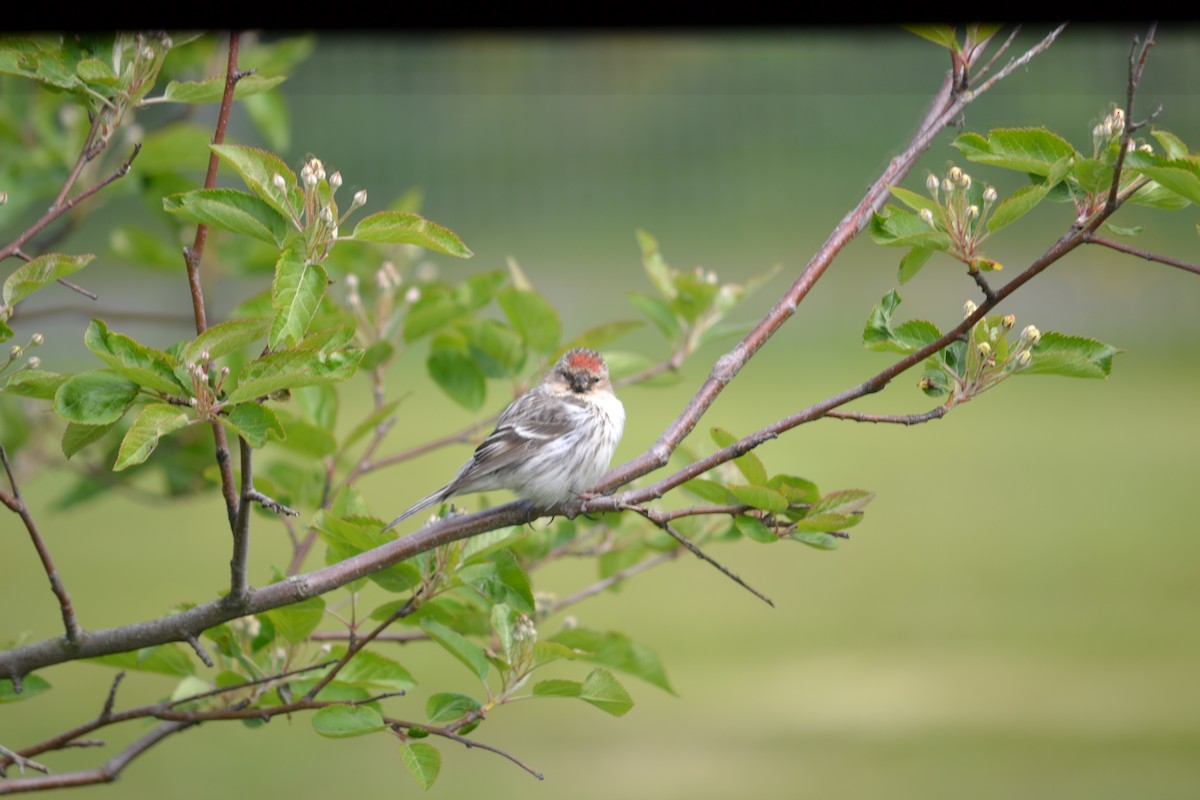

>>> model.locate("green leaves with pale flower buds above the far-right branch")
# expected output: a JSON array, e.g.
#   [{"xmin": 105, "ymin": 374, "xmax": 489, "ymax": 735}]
[{"xmin": 870, "ymin": 109, "xmax": 1200, "ymax": 283}]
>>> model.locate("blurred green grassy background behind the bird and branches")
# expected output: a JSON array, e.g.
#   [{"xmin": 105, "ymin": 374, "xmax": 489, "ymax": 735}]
[{"xmin": 0, "ymin": 26, "xmax": 1200, "ymax": 799}]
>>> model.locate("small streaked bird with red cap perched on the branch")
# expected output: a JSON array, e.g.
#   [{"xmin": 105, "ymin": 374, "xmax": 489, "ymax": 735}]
[{"xmin": 384, "ymin": 348, "xmax": 625, "ymax": 530}]
